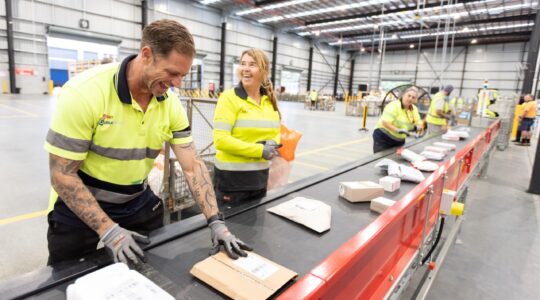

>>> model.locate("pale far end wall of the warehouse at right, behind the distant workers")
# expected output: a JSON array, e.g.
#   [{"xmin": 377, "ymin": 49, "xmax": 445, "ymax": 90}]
[{"xmin": 354, "ymin": 43, "xmax": 529, "ymax": 97}]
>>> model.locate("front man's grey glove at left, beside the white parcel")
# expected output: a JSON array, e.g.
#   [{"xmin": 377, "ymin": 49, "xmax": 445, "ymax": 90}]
[{"xmin": 101, "ymin": 223, "xmax": 150, "ymax": 265}]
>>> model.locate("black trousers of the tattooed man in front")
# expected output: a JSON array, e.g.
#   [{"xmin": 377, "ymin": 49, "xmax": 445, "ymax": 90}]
[{"xmin": 47, "ymin": 191, "xmax": 163, "ymax": 265}]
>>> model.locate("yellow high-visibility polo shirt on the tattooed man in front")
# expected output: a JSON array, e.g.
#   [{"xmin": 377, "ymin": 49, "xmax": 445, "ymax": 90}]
[{"xmin": 44, "ymin": 55, "xmax": 192, "ymax": 209}]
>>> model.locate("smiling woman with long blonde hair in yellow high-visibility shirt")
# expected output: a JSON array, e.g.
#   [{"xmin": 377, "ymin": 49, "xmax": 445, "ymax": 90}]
[{"xmin": 213, "ymin": 49, "xmax": 280, "ymax": 209}]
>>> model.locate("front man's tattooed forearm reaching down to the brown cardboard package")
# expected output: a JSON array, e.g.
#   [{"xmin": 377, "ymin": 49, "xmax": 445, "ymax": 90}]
[{"xmin": 173, "ymin": 143, "xmax": 218, "ymax": 218}]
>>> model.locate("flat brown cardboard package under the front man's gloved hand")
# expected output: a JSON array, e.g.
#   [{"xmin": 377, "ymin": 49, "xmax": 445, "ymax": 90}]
[{"xmin": 190, "ymin": 252, "xmax": 298, "ymax": 300}]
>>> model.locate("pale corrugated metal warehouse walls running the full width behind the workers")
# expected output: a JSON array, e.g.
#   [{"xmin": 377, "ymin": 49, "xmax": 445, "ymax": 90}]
[{"xmin": 0, "ymin": 0, "xmax": 528, "ymax": 97}]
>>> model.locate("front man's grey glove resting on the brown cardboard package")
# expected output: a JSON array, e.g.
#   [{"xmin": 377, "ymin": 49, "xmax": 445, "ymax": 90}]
[{"xmin": 208, "ymin": 220, "xmax": 253, "ymax": 259}]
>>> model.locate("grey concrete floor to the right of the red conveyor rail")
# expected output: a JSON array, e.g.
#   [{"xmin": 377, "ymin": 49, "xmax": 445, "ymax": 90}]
[{"xmin": 428, "ymin": 138, "xmax": 540, "ymax": 300}]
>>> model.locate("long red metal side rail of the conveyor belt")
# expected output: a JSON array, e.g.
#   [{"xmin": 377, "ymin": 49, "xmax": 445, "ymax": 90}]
[{"xmin": 279, "ymin": 120, "xmax": 501, "ymax": 299}]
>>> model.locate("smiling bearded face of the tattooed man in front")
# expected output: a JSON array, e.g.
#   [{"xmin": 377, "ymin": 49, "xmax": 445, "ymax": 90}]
[{"xmin": 141, "ymin": 46, "xmax": 193, "ymax": 97}]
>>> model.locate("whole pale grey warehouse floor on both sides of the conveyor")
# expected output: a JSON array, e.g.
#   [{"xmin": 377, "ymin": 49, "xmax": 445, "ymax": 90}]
[{"xmin": 0, "ymin": 95, "xmax": 540, "ymax": 299}]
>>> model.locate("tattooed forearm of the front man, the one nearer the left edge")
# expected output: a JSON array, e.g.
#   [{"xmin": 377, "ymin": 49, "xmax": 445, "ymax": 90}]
[{"xmin": 49, "ymin": 154, "xmax": 112, "ymax": 235}]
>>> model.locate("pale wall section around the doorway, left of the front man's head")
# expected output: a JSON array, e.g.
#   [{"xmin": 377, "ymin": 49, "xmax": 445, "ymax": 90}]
[{"xmin": 0, "ymin": 0, "xmax": 141, "ymax": 93}]
